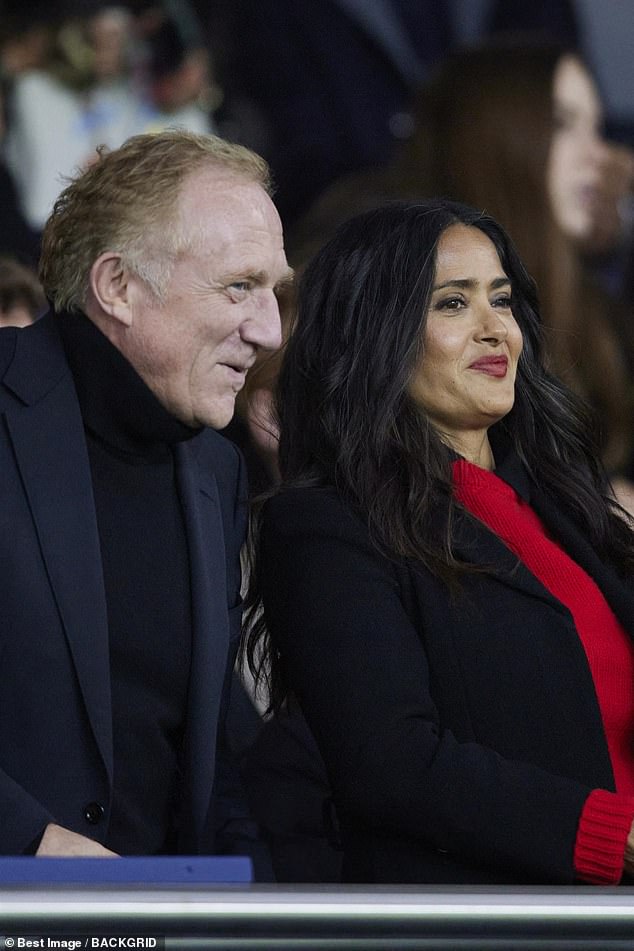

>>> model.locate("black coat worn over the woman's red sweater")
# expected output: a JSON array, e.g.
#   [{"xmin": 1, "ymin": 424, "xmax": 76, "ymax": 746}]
[{"xmin": 262, "ymin": 462, "xmax": 634, "ymax": 884}]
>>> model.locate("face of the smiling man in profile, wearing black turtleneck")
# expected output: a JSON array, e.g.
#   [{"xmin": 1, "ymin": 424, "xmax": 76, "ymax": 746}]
[{"xmin": 118, "ymin": 170, "xmax": 291, "ymax": 429}]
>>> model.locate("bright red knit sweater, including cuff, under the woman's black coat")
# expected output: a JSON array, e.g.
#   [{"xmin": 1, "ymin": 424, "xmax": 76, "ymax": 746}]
[{"xmin": 453, "ymin": 459, "xmax": 634, "ymax": 885}]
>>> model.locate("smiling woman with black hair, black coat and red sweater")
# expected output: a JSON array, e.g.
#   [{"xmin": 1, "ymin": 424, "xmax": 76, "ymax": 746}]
[{"xmin": 248, "ymin": 201, "xmax": 634, "ymax": 884}]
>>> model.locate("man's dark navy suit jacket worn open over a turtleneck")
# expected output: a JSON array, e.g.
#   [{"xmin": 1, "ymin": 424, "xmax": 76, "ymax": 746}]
[{"xmin": 0, "ymin": 315, "xmax": 246, "ymax": 854}]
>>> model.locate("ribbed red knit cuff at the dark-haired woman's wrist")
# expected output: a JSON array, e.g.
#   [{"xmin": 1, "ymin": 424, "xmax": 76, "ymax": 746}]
[{"xmin": 574, "ymin": 789, "xmax": 634, "ymax": 885}]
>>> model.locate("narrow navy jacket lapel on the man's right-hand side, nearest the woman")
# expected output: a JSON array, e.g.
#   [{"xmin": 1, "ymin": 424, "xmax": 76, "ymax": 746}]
[{"xmin": 176, "ymin": 437, "xmax": 229, "ymax": 847}]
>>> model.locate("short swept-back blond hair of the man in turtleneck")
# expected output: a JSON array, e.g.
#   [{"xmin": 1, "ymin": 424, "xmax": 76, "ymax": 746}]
[{"xmin": 39, "ymin": 130, "xmax": 271, "ymax": 311}]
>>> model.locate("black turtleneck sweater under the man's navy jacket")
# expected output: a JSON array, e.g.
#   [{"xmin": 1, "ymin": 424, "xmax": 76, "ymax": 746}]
[{"xmin": 58, "ymin": 314, "xmax": 196, "ymax": 855}]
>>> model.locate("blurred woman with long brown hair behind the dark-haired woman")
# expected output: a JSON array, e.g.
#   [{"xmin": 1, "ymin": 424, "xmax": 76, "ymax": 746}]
[{"xmin": 289, "ymin": 42, "xmax": 634, "ymax": 488}]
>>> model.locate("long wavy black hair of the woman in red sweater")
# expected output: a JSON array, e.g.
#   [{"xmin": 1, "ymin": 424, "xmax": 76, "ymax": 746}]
[{"xmin": 243, "ymin": 200, "xmax": 634, "ymax": 706}]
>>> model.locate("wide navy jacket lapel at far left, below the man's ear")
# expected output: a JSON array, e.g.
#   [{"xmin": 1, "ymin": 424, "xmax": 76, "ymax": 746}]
[{"xmin": 3, "ymin": 318, "xmax": 112, "ymax": 782}]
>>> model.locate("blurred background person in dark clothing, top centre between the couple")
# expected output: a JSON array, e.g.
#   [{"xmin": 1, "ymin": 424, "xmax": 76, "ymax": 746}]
[{"xmin": 218, "ymin": 0, "xmax": 451, "ymax": 226}]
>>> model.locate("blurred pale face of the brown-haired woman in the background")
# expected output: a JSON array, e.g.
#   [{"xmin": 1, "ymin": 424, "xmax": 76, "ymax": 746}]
[{"xmin": 547, "ymin": 56, "xmax": 609, "ymax": 242}]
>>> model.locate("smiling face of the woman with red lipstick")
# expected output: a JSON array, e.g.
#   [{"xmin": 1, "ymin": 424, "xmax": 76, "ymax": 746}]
[{"xmin": 410, "ymin": 224, "xmax": 522, "ymax": 461}]
